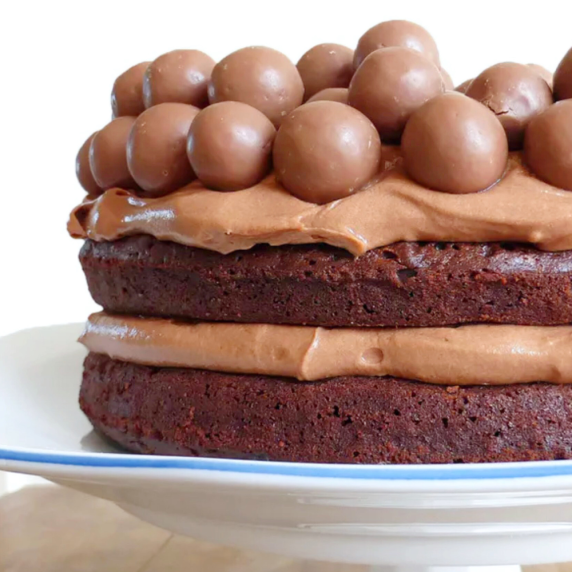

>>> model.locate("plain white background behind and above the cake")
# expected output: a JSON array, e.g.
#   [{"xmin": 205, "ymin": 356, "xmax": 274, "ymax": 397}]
[{"xmin": 0, "ymin": 0, "xmax": 572, "ymax": 489}]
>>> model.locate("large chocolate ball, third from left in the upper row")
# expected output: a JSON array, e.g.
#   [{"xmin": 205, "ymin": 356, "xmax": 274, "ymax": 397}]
[{"xmin": 209, "ymin": 46, "xmax": 304, "ymax": 126}]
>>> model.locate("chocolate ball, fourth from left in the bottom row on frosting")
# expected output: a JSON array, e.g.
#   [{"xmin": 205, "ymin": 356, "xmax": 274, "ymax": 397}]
[{"xmin": 187, "ymin": 101, "xmax": 276, "ymax": 191}]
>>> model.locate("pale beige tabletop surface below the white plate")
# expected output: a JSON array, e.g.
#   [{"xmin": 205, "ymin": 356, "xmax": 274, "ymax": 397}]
[{"xmin": 0, "ymin": 486, "xmax": 536, "ymax": 572}]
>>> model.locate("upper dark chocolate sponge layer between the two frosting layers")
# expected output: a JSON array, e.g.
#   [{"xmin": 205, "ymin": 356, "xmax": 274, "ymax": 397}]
[{"xmin": 80, "ymin": 236, "xmax": 572, "ymax": 327}]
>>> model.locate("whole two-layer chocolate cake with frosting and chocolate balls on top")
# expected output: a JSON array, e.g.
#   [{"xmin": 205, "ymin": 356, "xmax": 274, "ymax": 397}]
[{"xmin": 68, "ymin": 21, "xmax": 572, "ymax": 463}]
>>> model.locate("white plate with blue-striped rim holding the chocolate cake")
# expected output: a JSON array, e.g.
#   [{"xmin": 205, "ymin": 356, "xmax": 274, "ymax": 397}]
[{"xmin": 0, "ymin": 324, "xmax": 572, "ymax": 566}]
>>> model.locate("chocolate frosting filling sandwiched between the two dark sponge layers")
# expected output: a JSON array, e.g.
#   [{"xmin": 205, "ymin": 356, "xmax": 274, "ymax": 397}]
[{"xmin": 80, "ymin": 313, "xmax": 572, "ymax": 385}]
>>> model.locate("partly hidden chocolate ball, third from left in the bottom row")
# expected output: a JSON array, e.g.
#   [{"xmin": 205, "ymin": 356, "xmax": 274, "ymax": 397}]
[{"xmin": 127, "ymin": 103, "xmax": 199, "ymax": 197}]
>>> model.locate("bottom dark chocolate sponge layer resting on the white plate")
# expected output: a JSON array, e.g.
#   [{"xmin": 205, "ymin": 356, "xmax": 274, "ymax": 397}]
[{"xmin": 80, "ymin": 353, "xmax": 572, "ymax": 463}]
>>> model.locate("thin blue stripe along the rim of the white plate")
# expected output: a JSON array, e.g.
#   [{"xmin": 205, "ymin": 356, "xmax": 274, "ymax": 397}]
[{"xmin": 0, "ymin": 449, "xmax": 572, "ymax": 481}]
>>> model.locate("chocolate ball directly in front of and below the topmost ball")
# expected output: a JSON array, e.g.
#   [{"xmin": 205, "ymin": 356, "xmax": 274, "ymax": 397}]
[{"xmin": 348, "ymin": 48, "xmax": 444, "ymax": 142}]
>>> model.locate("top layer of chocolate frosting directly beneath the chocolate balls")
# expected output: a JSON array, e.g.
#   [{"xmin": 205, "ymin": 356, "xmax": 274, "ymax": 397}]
[{"xmin": 68, "ymin": 147, "xmax": 572, "ymax": 256}]
